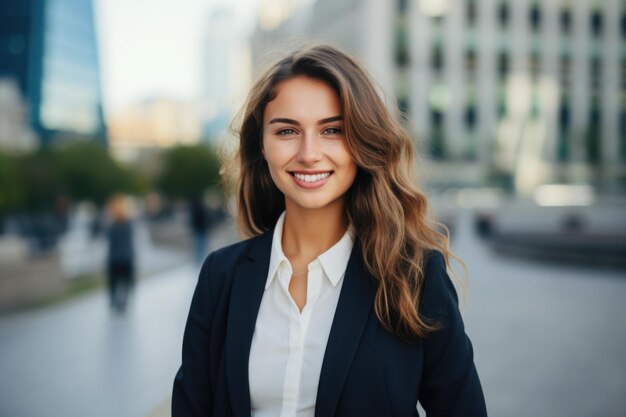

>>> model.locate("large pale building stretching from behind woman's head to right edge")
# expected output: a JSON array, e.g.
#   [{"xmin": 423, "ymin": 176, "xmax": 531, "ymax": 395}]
[{"xmin": 253, "ymin": 0, "xmax": 626, "ymax": 192}]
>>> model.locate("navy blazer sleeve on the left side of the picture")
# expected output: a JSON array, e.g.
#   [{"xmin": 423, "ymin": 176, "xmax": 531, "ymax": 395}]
[{"xmin": 172, "ymin": 254, "xmax": 214, "ymax": 417}]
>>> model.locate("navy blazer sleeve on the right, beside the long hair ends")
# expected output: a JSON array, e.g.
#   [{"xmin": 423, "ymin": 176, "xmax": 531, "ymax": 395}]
[{"xmin": 419, "ymin": 251, "xmax": 487, "ymax": 417}]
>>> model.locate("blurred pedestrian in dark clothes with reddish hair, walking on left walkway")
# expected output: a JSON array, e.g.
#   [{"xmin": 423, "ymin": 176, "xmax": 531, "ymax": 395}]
[{"xmin": 107, "ymin": 195, "xmax": 135, "ymax": 313}]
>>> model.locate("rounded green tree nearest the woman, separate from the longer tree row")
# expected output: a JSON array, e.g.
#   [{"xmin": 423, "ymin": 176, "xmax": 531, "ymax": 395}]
[{"xmin": 158, "ymin": 145, "xmax": 219, "ymax": 198}]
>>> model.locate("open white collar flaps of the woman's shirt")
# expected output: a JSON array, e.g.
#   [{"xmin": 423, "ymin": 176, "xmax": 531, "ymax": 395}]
[{"xmin": 265, "ymin": 211, "xmax": 354, "ymax": 289}]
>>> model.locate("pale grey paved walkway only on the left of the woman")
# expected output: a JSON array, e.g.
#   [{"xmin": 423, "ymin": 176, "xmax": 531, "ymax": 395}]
[{"xmin": 0, "ymin": 218, "xmax": 235, "ymax": 417}]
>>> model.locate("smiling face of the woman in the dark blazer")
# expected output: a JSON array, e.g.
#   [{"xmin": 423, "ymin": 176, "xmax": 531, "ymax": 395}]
[{"xmin": 263, "ymin": 76, "xmax": 357, "ymax": 216}]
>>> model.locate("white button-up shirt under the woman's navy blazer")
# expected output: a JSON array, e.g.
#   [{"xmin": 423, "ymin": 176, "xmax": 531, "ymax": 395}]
[{"xmin": 248, "ymin": 213, "xmax": 353, "ymax": 417}]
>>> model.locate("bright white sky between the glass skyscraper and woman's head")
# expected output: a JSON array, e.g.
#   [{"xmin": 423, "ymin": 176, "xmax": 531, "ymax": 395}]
[{"xmin": 94, "ymin": 0, "xmax": 257, "ymax": 115}]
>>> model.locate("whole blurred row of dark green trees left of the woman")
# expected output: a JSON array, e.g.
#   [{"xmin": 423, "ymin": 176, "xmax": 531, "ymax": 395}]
[{"xmin": 0, "ymin": 141, "xmax": 219, "ymax": 215}]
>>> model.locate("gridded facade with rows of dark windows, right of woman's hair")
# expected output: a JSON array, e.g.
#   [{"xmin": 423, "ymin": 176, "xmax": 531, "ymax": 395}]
[{"xmin": 407, "ymin": 0, "xmax": 626, "ymax": 189}]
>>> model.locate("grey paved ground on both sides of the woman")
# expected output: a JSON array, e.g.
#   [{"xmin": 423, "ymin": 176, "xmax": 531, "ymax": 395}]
[{"xmin": 0, "ymin": 212, "xmax": 626, "ymax": 417}]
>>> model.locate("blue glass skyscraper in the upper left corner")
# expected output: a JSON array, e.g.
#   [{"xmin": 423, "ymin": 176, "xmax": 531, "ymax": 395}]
[{"xmin": 0, "ymin": 0, "xmax": 106, "ymax": 146}]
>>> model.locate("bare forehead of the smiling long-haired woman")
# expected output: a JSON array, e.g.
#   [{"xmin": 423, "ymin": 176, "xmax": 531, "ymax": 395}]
[{"xmin": 263, "ymin": 76, "xmax": 341, "ymax": 123}]
